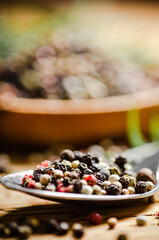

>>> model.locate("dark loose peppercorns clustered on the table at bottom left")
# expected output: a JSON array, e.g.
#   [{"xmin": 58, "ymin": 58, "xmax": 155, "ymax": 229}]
[{"xmin": 0, "ymin": 217, "xmax": 84, "ymax": 239}]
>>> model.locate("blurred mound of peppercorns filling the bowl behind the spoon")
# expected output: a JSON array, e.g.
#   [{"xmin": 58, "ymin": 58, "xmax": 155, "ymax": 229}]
[{"xmin": 0, "ymin": 33, "xmax": 158, "ymax": 100}]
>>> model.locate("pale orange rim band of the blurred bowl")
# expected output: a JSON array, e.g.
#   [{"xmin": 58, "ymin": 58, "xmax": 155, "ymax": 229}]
[{"xmin": 0, "ymin": 86, "xmax": 159, "ymax": 115}]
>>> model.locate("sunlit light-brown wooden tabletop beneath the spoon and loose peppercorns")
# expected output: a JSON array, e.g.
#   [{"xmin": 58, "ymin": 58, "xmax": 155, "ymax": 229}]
[{"xmin": 0, "ymin": 163, "xmax": 159, "ymax": 240}]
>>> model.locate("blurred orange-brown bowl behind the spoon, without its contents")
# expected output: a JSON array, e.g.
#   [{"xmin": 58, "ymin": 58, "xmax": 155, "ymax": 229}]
[{"xmin": 0, "ymin": 88, "xmax": 159, "ymax": 147}]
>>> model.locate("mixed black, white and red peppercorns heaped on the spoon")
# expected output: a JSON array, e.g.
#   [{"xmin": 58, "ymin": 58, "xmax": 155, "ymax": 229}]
[{"xmin": 22, "ymin": 149, "xmax": 155, "ymax": 195}]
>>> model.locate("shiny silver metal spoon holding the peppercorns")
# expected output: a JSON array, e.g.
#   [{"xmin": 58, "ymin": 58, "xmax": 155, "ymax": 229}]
[{"xmin": 0, "ymin": 147, "xmax": 159, "ymax": 206}]
